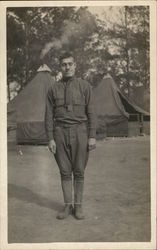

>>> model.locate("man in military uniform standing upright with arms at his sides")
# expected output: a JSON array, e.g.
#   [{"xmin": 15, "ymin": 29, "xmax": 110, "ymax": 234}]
[{"xmin": 45, "ymin": 53, "xmax": 96, "ymax": 220}]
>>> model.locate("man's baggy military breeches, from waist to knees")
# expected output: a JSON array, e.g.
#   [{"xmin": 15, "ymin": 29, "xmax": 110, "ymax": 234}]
[{"xmin": 54, "ymin": 124, "xmax": 89, "ymax": 181}]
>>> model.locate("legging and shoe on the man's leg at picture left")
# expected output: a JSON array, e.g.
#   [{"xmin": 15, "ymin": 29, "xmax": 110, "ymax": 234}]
[{"xmin": 57, "ymin": 180, "xmax": 73, "ymax": 220}]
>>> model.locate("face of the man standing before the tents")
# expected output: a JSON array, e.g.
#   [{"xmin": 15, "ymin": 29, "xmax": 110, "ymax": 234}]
[{"xmin": 61, "ymin": 57, "xmax": 76, "ymax": 77}]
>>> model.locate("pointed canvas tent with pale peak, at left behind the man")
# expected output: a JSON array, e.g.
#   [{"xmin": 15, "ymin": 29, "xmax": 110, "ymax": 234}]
[{"xmin": 7, "ymin": 64, "xmax": 54, "ymax": 144}]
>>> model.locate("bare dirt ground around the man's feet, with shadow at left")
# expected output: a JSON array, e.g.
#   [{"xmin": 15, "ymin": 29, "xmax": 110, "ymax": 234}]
[{"xmin": 8, "ymin": 137, "xmax": 150, "ymax": 243}]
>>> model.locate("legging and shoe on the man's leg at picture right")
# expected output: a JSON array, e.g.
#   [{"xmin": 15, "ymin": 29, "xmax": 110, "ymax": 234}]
[{"xmin": 74, "ymin": 180, "xmax": 85, "ymax": 220}]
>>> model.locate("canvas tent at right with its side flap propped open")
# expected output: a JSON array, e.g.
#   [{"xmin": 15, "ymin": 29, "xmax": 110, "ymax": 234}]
[{"xmin": 93, "ymin": 75, "xmax": 149, "ymax": 136}]
